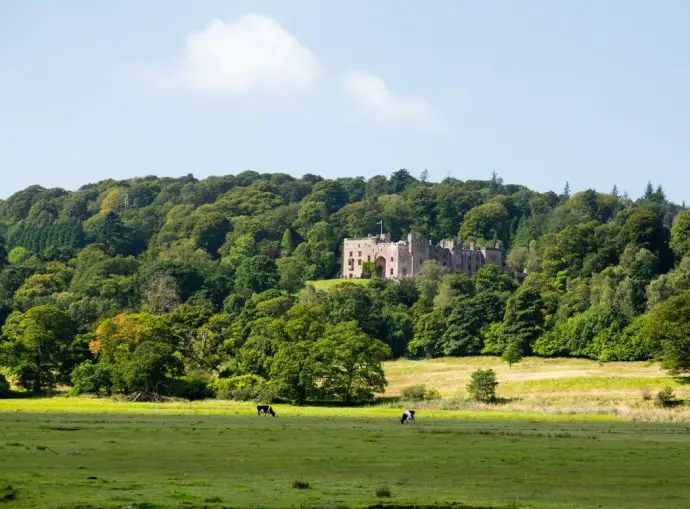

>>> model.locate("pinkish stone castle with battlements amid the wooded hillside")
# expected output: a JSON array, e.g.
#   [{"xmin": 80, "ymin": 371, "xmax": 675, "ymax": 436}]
[{"xmin": 342, "ymin": 234, "xmax": 503, "ymax": 279}]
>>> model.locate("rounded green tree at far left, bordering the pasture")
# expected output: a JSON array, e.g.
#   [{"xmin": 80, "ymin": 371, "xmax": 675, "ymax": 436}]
[{"xmin": 0, "ymin": 305, "xmax": 78, "ymax": 392}]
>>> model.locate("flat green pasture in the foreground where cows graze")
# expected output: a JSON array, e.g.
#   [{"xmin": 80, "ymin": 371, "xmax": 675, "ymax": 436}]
[{"xmin": 0, "ymin": 398, "xmax": 690, "ymax": 509}]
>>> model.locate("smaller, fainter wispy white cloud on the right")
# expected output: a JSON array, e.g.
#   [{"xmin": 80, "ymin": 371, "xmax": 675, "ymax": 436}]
[{"xmin": 342, "ymin": 71, "xmax": 438, "ymax": 129}]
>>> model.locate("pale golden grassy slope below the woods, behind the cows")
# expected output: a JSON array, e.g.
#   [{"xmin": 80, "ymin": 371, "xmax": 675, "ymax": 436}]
[{"xmin": 385, "ymin": 357, "xmax": 690, "ymax": 422}]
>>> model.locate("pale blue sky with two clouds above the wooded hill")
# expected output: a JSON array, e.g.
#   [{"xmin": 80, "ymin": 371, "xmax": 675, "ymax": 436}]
[{"xmin": 0, "ymin": 0, "xmax": 690, "ymax": 203}]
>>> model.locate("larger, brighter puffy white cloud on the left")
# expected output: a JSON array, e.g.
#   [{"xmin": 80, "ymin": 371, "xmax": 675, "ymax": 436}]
[{"xmin": 145, "ymin": 14, "xmax": 322, "ymax": 95}]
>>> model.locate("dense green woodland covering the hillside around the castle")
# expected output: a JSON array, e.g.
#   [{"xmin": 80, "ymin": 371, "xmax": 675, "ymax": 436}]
[{"xmin": 0, "ymin": 170, "xmax": 690, "ymax": 403}]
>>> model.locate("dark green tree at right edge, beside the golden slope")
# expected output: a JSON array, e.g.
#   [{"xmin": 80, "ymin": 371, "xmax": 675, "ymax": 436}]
[{"xmin": 644, "ymin": 291, "xmax": 690, "ymax": 374}]
